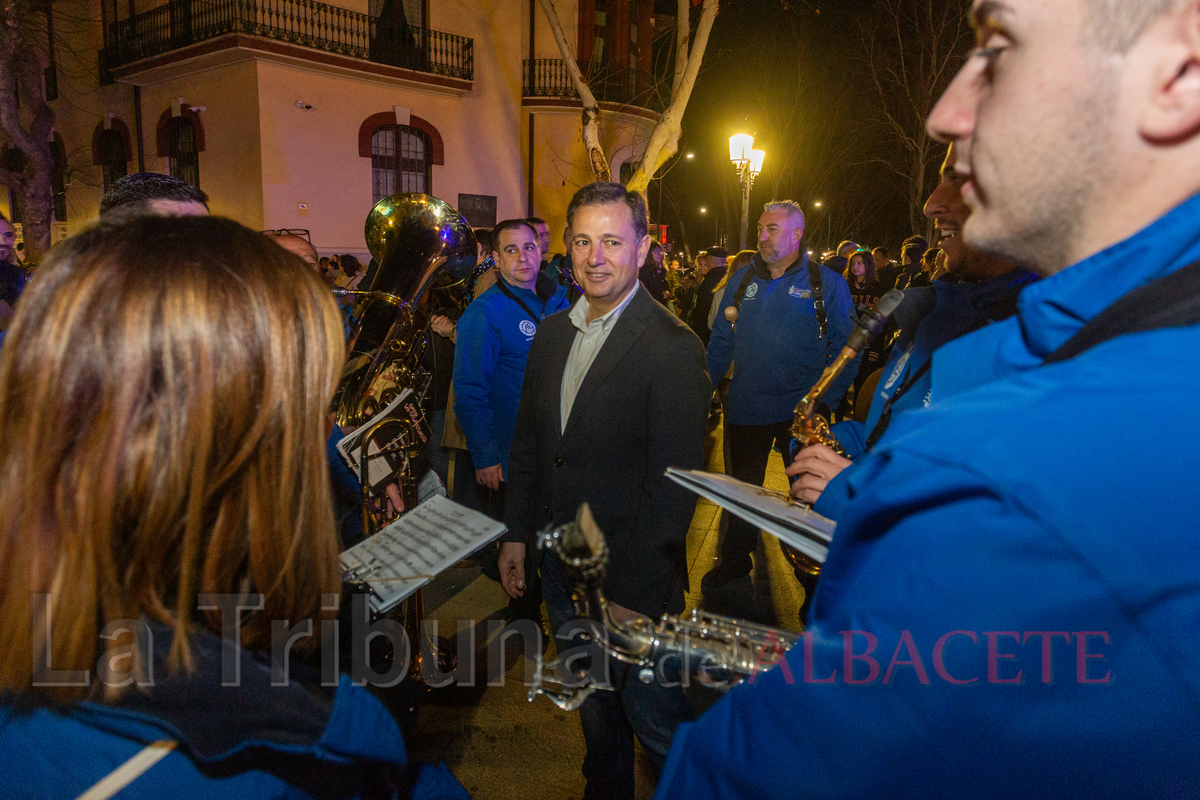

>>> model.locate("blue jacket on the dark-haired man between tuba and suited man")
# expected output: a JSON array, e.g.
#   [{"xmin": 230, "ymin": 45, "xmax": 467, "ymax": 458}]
[{"xmin": 454, "ymin": 275, "xmax": 570, "ymax": 476}]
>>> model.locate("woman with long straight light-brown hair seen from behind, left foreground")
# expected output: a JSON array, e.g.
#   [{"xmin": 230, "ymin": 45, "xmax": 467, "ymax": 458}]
[{"xmin": 0, "ymin": 217, "xmax": 466, "ymax": 800}]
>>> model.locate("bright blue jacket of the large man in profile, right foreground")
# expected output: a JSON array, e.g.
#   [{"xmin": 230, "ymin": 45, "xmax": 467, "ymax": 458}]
[{"xmin": 655, "ymin": 190, "xmax": 1200, "ymax": 800}]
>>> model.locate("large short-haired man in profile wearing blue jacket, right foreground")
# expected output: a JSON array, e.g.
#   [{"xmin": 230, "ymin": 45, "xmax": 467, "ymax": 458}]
[{"xmin": 656, "ymin": 0, "xmax": 1200, "ymax": 800}]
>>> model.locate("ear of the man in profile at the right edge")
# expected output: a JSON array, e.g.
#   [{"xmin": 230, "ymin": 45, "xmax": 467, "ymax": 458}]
[{"xmin": 1134, "ymin": 0, "xmax": 1200, "ymax": 143}]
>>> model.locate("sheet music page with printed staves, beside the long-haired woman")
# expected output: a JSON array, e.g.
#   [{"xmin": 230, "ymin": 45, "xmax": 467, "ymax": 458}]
[{"xmin": 341, "ymin": 494, "xmax": 508, "ymax": 613}]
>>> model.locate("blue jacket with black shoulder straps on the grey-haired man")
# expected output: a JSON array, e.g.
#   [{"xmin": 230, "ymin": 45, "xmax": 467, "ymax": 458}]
[{"xmin": 708, "ymin": 247, "xmax": 858, "ymax": 425}]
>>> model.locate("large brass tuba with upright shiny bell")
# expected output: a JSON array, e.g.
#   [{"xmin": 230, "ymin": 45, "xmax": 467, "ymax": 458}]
[{"xmin": 332, "ymin": 194, "xmax": 475, "ymax": 522}]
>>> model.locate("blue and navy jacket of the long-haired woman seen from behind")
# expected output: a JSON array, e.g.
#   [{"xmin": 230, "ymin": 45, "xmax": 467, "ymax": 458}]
[{"xmin": 0, "ymin": 624, "xmax": 467, "ymax": 800}]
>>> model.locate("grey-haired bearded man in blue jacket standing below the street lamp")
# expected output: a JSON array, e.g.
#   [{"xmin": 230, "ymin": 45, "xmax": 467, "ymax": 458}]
[{"xmin": 701, "ymin": 200, "xmax": 858, "ymax": 612}]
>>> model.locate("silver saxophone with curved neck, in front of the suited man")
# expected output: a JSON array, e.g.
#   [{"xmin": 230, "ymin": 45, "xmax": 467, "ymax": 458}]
[{"xmin": 528, "ymin": 503, "xmax": 799, "ymax": 711}]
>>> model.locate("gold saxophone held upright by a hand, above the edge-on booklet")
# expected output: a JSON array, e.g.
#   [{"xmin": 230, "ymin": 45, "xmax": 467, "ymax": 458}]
[{"xmin": 780, "ymin": 289, "xmax": 904, "ymax": 582}]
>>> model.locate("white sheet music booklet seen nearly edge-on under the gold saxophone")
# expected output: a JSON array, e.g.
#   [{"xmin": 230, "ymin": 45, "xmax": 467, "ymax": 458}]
[{"xmin": 666, "ymin": 467, "xmax": 838, "ymax": 564}]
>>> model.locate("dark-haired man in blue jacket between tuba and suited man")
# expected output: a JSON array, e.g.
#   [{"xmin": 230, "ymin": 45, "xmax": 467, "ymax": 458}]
[{"xmin": 454, "ymin": 219, "xmax": 569, "ymax": 513}]
